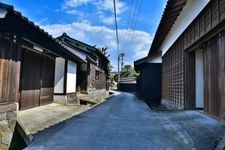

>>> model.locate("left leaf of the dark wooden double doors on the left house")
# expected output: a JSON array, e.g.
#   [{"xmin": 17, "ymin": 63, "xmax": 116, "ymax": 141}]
[{"xmin": 20, "ymin": 49, "xmax": 41, "ymax": 110}]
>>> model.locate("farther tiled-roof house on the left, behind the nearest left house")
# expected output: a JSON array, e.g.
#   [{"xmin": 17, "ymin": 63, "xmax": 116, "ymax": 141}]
[{"xmin": 57, "ymin": 33, "xmax": 110, "ymax": 92}]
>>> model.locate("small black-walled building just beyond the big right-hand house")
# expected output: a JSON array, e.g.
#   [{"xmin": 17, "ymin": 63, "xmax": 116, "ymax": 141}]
[{"xmin": 134, "ymin": 52, "xmax": 162, "ymax": 106}]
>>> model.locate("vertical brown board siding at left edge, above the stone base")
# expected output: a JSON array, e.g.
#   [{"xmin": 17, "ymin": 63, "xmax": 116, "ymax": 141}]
[{"xmin": 0, "ymin": 31, "xmax": 21, "ymax": 104}]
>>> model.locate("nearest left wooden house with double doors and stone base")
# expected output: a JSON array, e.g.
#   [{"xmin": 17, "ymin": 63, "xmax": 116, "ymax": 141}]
[{"xmin": 0, "ymin": 3, "xmax": 85, "ymax": 149}]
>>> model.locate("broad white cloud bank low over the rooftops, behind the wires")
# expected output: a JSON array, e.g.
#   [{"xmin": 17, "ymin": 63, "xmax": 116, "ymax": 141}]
[{"xmin": 41, "ymin": 22, "xmax": 153, "ymax": 70}]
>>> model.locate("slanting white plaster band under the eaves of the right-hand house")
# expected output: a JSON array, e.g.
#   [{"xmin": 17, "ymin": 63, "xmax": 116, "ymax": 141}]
[{"xmin": 160, "ymin": 0, "xmax": 209, "ymax": 56}]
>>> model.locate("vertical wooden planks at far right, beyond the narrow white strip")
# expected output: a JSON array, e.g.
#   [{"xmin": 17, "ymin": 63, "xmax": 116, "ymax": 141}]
[{"xmin": 203, "ymin": 34, "xmax": 225, "ymax": 119}]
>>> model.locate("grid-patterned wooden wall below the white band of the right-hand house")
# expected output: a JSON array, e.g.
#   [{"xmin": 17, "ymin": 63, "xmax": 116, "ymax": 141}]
[{"xmin": 162, "ymin": 0, "xmax": 225, "ymax": 108}]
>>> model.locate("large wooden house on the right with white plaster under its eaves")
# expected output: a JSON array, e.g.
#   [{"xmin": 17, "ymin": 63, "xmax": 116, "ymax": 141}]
[{"xmin": 149, "ymin": 0, "xmax": 225, "ymax": 119}]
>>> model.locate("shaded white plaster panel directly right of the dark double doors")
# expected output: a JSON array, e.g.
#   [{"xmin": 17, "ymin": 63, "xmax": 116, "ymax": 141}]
[{"xmin": 54, "ymin": 57, "xmax": 65, "ymax": 93}]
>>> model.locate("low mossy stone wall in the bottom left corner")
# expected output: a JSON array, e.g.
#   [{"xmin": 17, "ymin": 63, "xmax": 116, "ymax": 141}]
[{"xmin": 0, "ymin": 104, "xmax": 17, "ymax": 150}]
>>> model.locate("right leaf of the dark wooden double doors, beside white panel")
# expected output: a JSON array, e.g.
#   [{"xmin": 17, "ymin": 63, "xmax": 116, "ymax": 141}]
[{"xmin": 40, "ymin": 56, "xmax": 55, "ymax": 105}]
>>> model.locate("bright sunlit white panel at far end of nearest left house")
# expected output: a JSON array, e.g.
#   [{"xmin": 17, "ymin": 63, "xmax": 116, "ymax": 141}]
[{"xmin": 66, "ymin": 61, "xmax": 77, "ymax": 93}]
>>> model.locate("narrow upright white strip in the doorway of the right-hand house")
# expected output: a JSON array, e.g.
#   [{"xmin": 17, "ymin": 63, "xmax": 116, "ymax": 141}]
[{"xmin": 195, "ymin": 50, "xmax": 204, "ymax": 108}]
